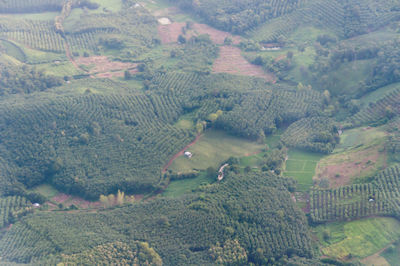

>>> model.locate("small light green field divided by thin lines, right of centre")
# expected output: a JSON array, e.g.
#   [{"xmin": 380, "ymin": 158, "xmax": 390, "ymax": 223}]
[{"xmin": 283, "ymin": 150, "xmax": 323, "ymax": 191}]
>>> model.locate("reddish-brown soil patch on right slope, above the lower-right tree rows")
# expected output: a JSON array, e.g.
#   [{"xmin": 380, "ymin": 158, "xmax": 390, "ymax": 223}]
[{"xmin": 317, "ymin": 149, "xmax": 384, "ymax": 188}]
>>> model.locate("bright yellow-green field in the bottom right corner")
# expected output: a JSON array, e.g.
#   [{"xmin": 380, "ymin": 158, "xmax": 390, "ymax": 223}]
[{"xmin": 315, "ymin": 218, "xmax": 400, "ymax": 259}]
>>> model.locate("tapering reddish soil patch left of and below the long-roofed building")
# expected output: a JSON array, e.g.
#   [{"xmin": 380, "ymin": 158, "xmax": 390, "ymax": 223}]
[{"xmin": 213, "ymin": 46, "xmax": 276, "ymax": 83}]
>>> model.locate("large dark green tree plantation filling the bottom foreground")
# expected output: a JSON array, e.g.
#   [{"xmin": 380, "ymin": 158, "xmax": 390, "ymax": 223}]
[{"xmin": 0, "ymin": 172, "xmax": 313, "ymax": 265}]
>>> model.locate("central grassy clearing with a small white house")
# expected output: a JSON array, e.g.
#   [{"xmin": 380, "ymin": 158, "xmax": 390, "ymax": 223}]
[{"xmin": 169, "ymin": 130, "xmax": 265, "ymax": 172}]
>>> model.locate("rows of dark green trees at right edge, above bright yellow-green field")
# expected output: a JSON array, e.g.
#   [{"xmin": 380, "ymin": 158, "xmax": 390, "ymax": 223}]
[{"xmin": 310, "ymin": 165, "xmax": 400, "ymax": 222}]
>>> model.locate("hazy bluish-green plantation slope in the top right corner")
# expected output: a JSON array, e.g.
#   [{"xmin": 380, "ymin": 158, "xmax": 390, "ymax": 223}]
[{"xmin": 246, "ymin": 0, "xmax": 400, "ymax": 42}]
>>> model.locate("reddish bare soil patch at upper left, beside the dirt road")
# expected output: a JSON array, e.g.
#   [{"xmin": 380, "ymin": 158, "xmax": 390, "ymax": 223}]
[{"xmin": 75, "ymin": 56, "xmax": 137, "ymax": 75}]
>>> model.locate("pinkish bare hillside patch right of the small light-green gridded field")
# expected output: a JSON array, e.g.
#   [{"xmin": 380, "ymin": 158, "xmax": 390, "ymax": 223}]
[{"xmin": 314, "ymin": 146, "xmax": 386, "ymax": 188}]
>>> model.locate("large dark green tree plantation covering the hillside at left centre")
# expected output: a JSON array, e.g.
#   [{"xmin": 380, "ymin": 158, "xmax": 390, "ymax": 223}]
[{"xmin": 0, "ymin": 79, "xmax": 194, "ymax": 198}]
